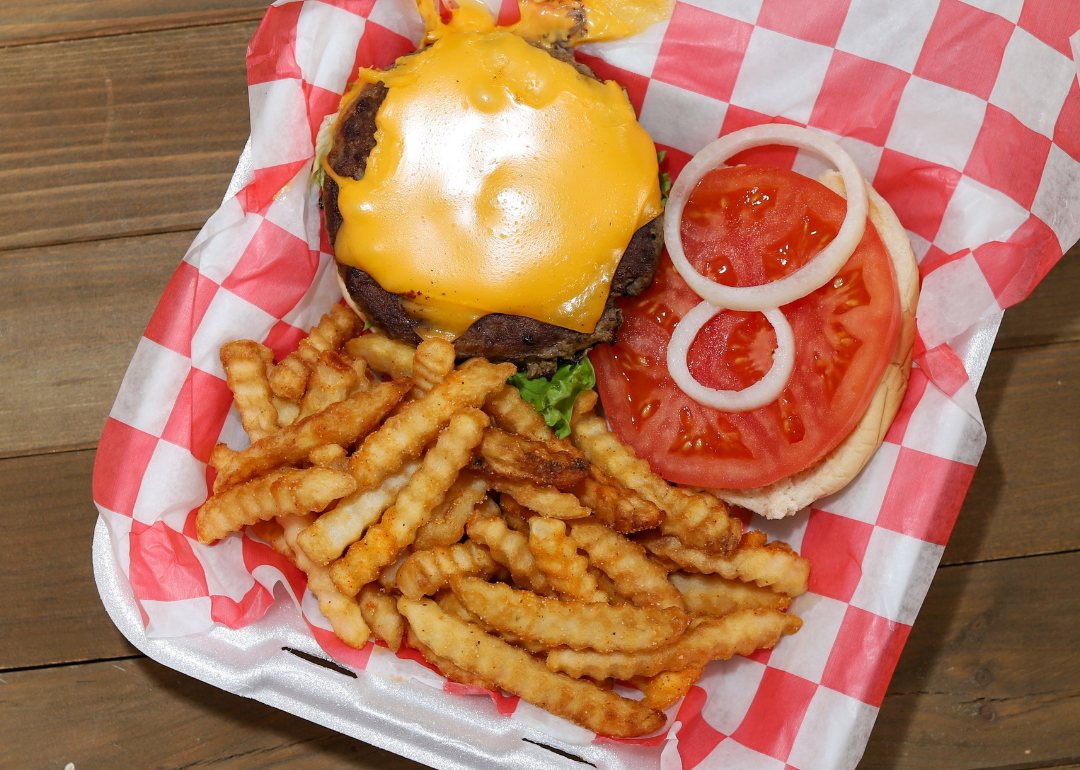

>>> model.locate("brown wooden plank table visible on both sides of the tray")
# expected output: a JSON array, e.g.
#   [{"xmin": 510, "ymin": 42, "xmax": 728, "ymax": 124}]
[{"xmin": 0, "ymin": 6, "xmax": 1080, "ymax": 769}]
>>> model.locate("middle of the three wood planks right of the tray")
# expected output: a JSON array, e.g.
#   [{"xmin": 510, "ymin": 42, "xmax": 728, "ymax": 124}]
[{"xmin": 943, "ymin": 342, "xmax": 1080, "ymax": 564}]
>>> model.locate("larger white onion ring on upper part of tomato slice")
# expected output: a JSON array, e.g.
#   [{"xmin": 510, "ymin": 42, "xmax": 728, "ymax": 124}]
[{"xmin": 664, "ymin": 124, "xmax": 868, "ymax": 312}]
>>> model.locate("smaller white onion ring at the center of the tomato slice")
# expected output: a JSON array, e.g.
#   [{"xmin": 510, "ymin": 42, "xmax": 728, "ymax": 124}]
[{"xmin": 667, "ymin": 302, "xmax": 795, "ymax": 411}]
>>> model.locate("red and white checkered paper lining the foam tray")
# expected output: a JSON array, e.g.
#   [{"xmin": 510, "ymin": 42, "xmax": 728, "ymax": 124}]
[{"xmin": 88, "ymin": 0, "xmax": 1080, "ymax": 770}]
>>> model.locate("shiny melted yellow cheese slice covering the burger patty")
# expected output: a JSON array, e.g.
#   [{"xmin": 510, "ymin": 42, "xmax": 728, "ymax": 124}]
[{"xmin": 324, "ymin": 27, "xmax": 661, "ymax": 339}]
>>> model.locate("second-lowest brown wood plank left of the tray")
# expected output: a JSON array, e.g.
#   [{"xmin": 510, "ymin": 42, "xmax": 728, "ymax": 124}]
[{"xmin": 0, "ymin": 451, "xmax": 138, "ymax": 669}]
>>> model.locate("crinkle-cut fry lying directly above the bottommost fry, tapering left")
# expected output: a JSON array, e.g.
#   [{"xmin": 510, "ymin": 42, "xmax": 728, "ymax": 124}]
[{"xmin": 449, "ymin": 576, "xmax": 690, "ymax": 652}]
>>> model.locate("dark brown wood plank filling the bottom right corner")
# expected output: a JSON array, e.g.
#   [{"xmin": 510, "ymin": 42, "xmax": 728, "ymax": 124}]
[{"xmin": 859, "ymin": 553, "xmax": 1080, "ymax": 770}]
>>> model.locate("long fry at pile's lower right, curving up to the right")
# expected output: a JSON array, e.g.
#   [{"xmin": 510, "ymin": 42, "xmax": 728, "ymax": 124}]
[{"xmin": 548, "ymin": 609, "xmax": 802, "ymax": 680}]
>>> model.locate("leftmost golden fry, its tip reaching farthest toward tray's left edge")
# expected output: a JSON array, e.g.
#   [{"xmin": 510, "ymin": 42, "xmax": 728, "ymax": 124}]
[{"xmin": 195, "ymin": 468, "xmax": 356, "ymax": 543}]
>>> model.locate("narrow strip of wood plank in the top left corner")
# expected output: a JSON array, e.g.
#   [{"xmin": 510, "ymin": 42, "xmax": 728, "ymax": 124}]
[{"xmin": 0, "ymin": 0, "xmax": 267, "ymax": 45}]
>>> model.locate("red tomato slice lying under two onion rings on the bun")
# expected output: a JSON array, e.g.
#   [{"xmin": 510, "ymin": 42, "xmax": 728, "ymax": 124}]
[{"xmin": 592, "ymin": 165, "xmax": 900, "ymax": 489}]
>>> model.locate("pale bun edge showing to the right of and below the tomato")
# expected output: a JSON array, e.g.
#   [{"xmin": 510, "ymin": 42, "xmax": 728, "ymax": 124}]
[{"xmin": 714, "ymin": 171, "xmax": 919, "ymax": 518}]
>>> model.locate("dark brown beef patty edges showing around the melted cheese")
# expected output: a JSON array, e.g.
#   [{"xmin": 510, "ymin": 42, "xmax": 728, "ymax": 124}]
[{"xmin": 322, "ymin": 55, "xmax": 663, "ymax": 377}]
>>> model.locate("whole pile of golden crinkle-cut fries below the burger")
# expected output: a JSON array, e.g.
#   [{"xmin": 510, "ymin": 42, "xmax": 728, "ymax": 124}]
[{"xmin": 197, "ymin": 306, "xmax": 810, "ymax": 738}]
